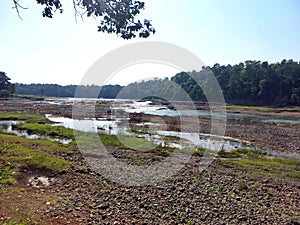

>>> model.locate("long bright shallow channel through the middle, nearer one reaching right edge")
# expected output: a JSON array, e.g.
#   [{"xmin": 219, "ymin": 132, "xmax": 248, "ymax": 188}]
[{"xmin": 48, "ymin": 117, "xmax": 300, "ymax": 158}]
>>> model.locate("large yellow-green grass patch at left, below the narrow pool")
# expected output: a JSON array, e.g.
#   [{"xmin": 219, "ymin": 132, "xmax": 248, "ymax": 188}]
[{"xmin": 0, "ymin": 133, "xmax": 72, "ymax": 186}]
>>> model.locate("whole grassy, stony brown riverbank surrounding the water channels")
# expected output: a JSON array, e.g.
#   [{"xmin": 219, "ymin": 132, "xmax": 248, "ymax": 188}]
[{"xmin": 0, "ymin": 97, "xmax": 300, "ymax": 225}]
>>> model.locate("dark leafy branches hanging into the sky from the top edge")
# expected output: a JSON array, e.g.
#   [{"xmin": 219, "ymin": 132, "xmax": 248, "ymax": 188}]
[{"xmin": 13, "ymin": 0, "xmax": 155, "ymax": 39}]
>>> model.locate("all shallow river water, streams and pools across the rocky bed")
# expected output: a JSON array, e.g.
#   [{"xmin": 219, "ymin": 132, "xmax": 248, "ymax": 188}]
[{"xmin": 0, "ymin": 98, "xmax": 300, "ymax": 158}]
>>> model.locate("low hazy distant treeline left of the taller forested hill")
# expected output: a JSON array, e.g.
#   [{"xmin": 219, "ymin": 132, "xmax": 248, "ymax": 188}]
[{"xmin": 16, "ymin": 83, "xmax": 122, "ymax": 98}]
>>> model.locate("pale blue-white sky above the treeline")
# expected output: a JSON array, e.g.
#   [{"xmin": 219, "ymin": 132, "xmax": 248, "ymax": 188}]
[{"xmin": 0, "ymin": 0, "xmax": 300, "ymax": 85}]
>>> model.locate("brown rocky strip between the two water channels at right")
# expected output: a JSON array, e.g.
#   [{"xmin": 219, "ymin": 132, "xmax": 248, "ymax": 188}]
[{"xmin": 131, "ymin": 113, "xmax": 300, "ymax": 154}]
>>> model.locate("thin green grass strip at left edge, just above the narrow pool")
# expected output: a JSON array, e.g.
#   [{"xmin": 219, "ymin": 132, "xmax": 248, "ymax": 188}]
[{"xmin": 0, "ymin": 113, "xmax": 50, "ymax": 123}]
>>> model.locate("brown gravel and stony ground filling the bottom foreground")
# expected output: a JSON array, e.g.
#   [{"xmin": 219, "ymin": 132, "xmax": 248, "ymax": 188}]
[{"xmin": 0, "ymin": 147, "xmax": 300, "ymax": 225}]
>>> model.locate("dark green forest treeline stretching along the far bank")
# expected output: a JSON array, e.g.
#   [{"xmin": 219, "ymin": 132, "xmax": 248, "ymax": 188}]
[{"xmin": 16, "ymin": 59, "xmax": 300, "ymax": 106}]
